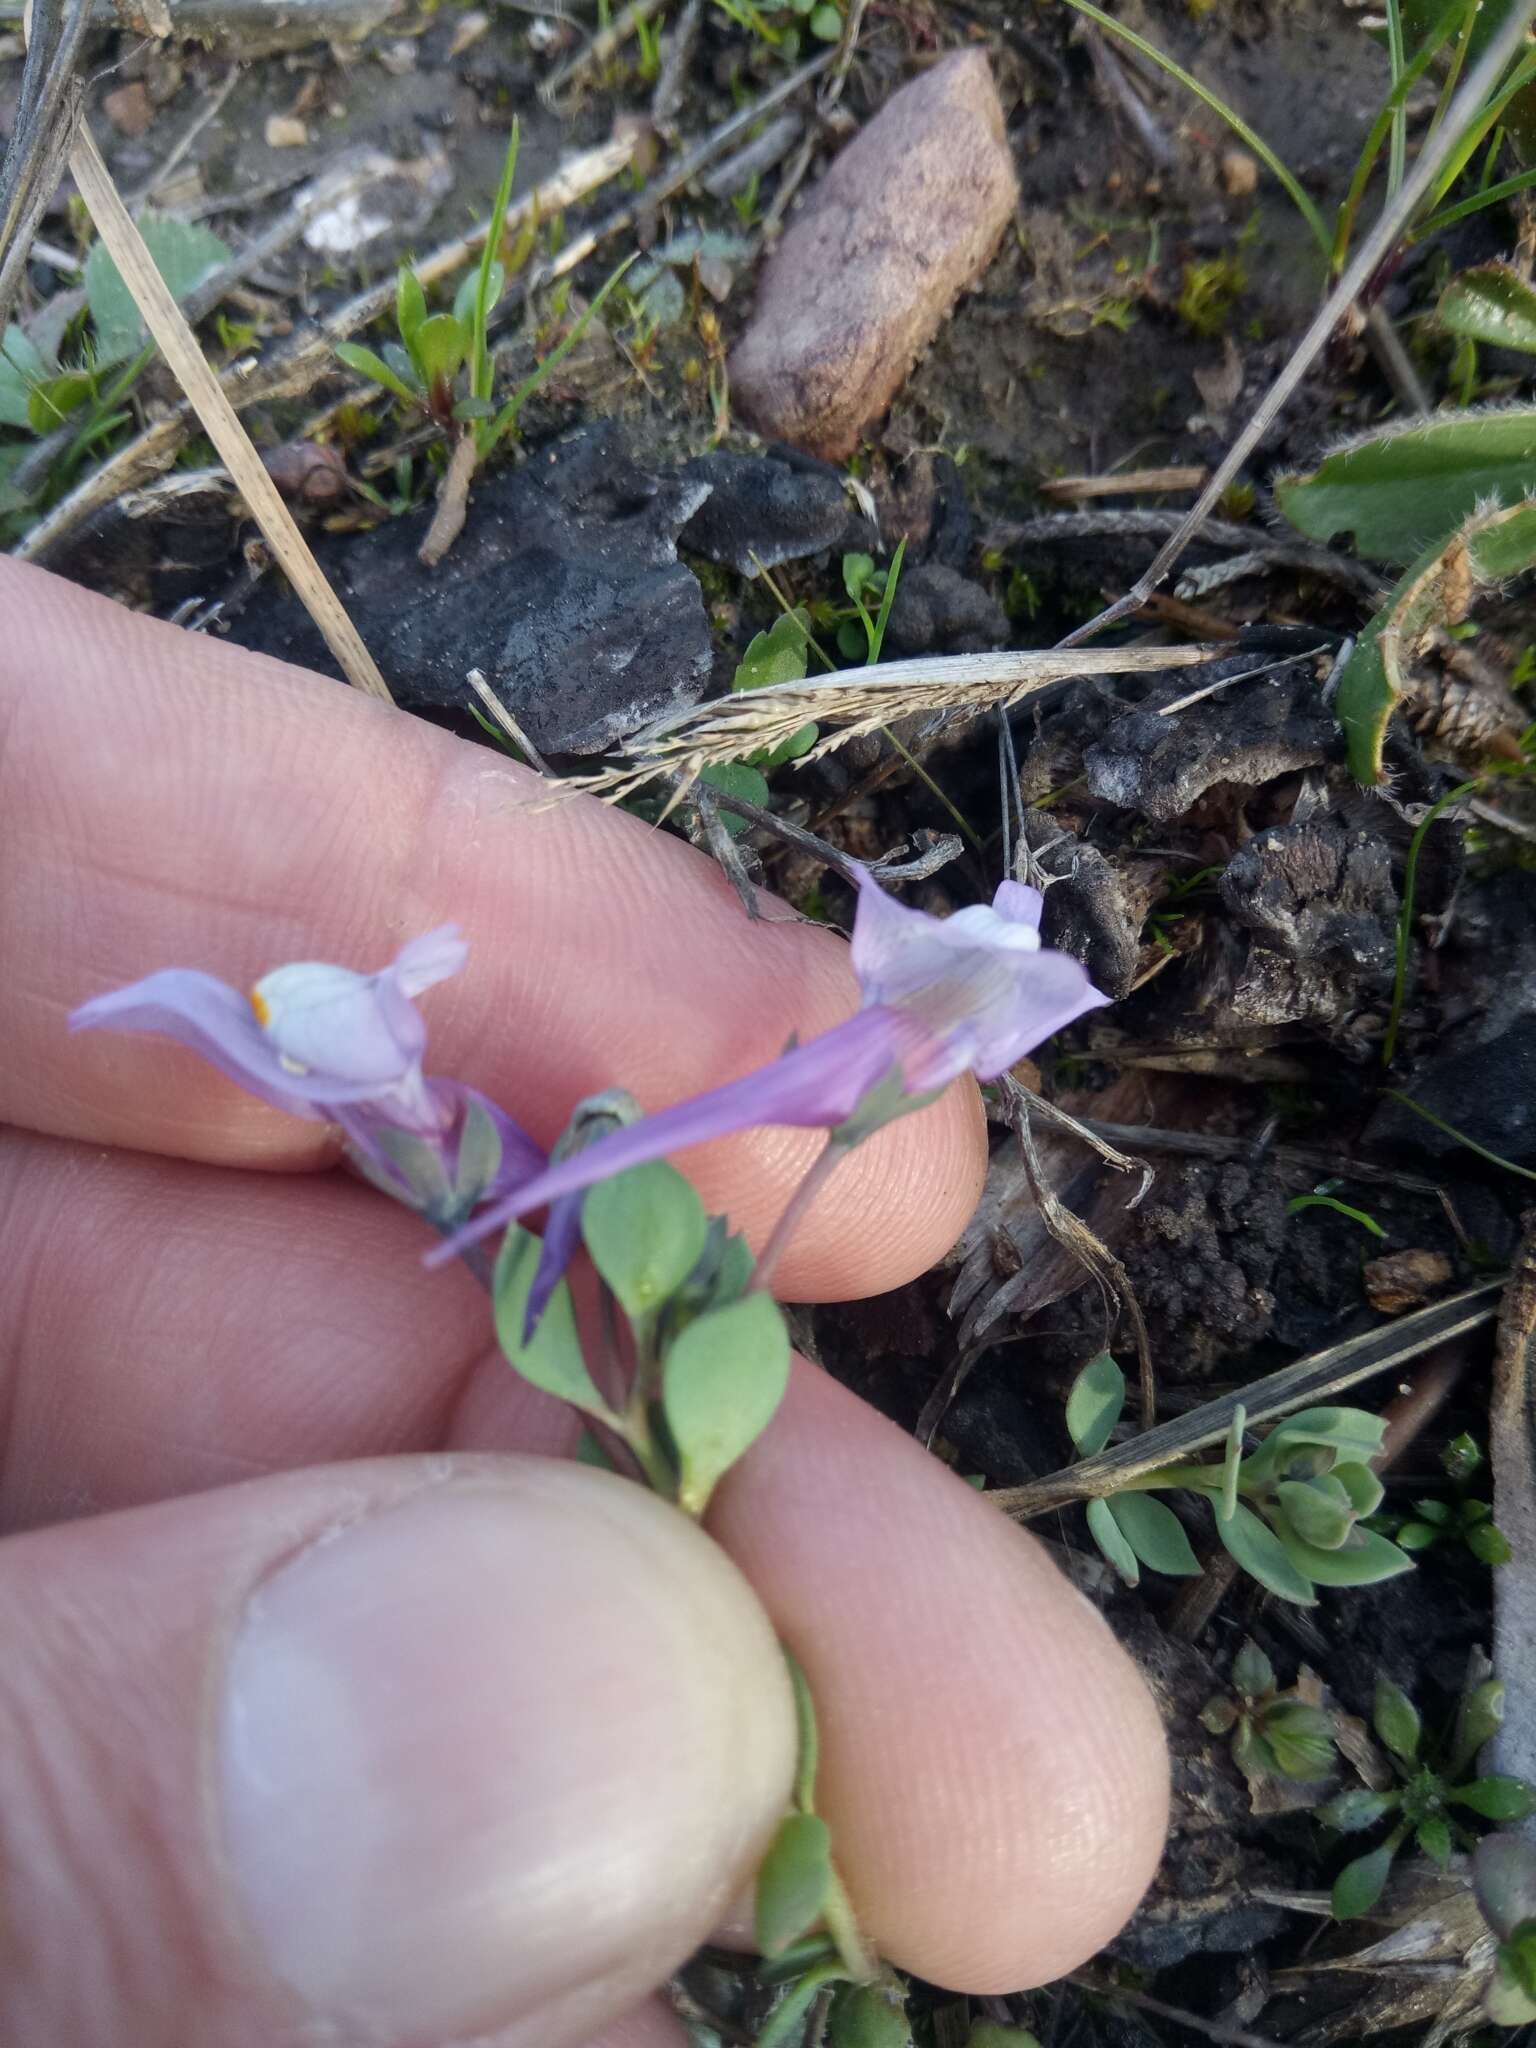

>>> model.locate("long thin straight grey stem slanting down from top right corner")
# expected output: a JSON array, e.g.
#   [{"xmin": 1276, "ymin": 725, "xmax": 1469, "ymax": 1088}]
[{"xmin": 1061, "ymin": 0, "xmax": 1536, "ymax": 647}]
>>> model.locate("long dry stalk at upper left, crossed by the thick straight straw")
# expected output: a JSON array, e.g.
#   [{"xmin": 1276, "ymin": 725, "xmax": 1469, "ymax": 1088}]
[{"xmin": 14, "ymin": 137, "xmax": 637, "ymax": 561}]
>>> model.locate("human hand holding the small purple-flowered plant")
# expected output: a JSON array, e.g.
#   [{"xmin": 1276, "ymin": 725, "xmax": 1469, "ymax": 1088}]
[{"xmin": 0, "ymin": 561, "xmax": 1165, "ymax": 2048}]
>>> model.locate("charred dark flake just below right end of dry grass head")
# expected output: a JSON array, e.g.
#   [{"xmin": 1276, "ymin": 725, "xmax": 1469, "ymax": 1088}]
[{"xmin": 1083, "ymin": 655, "xmax": 1339, "ymax": 821}]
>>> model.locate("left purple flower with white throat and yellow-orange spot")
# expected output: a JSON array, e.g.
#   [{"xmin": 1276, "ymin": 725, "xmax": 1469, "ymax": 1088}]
[{"xmin": 70, "ymin": 924, "xmax": 545, "ymax": 1223}]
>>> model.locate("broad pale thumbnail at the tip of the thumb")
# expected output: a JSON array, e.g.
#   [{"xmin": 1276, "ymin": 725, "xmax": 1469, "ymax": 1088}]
[{"xmin": 219, "ymin": 1460, "xmax": 793, "ymax": 2040}]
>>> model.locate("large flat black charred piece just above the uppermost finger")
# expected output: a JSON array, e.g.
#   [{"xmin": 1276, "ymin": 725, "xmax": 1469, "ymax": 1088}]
[{"xmin": 219, "ymin": 426, "xmax": 713, "ymax": 754}]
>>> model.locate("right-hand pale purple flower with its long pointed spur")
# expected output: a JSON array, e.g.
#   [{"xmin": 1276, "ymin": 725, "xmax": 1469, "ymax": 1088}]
[{"xmin": 430, "ymin": 874, "xmax": 1110, "ymax": 1264}]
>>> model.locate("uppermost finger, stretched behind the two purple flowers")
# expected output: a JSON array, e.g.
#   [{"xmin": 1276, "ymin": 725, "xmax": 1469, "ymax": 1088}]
[{"xmin": 0, "ymin": 559, "xmax": 985, "ymax": 1298}]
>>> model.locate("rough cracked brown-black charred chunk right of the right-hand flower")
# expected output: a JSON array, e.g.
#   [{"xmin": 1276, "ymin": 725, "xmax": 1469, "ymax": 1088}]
[{"xmin": 1219, "ymin": 815, "xmax": 1399, "ymax": 1024}]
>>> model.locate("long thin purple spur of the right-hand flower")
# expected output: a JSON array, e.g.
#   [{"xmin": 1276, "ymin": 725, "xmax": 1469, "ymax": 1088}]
[{"xmin": 426, "ymin": 1006, "xmax": 918, "ymax": 1266}]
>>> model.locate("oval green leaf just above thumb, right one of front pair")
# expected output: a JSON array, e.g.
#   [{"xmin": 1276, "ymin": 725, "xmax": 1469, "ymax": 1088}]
[{"xmin": 662, "ymin": 1294, "xmax": 788, "ymax": 1516}]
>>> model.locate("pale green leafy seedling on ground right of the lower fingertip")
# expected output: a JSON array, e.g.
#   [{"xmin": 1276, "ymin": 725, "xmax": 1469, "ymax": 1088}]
[{"xmin": 1067, "ymin": 1352, "xmax": 1413, "ymax": 1608}]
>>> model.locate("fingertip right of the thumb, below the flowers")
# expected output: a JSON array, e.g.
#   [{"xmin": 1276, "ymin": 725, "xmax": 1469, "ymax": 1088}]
[{"xmin": 713, "ymin": 1366, "xmax": 1167, "ymax": 1993}]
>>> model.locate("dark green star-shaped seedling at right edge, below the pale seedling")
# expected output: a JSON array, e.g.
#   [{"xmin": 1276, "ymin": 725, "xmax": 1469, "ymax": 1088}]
[{"xmin": 1317, "ymin": 1677, "xmax": 1536, "ymax": 1919}]
